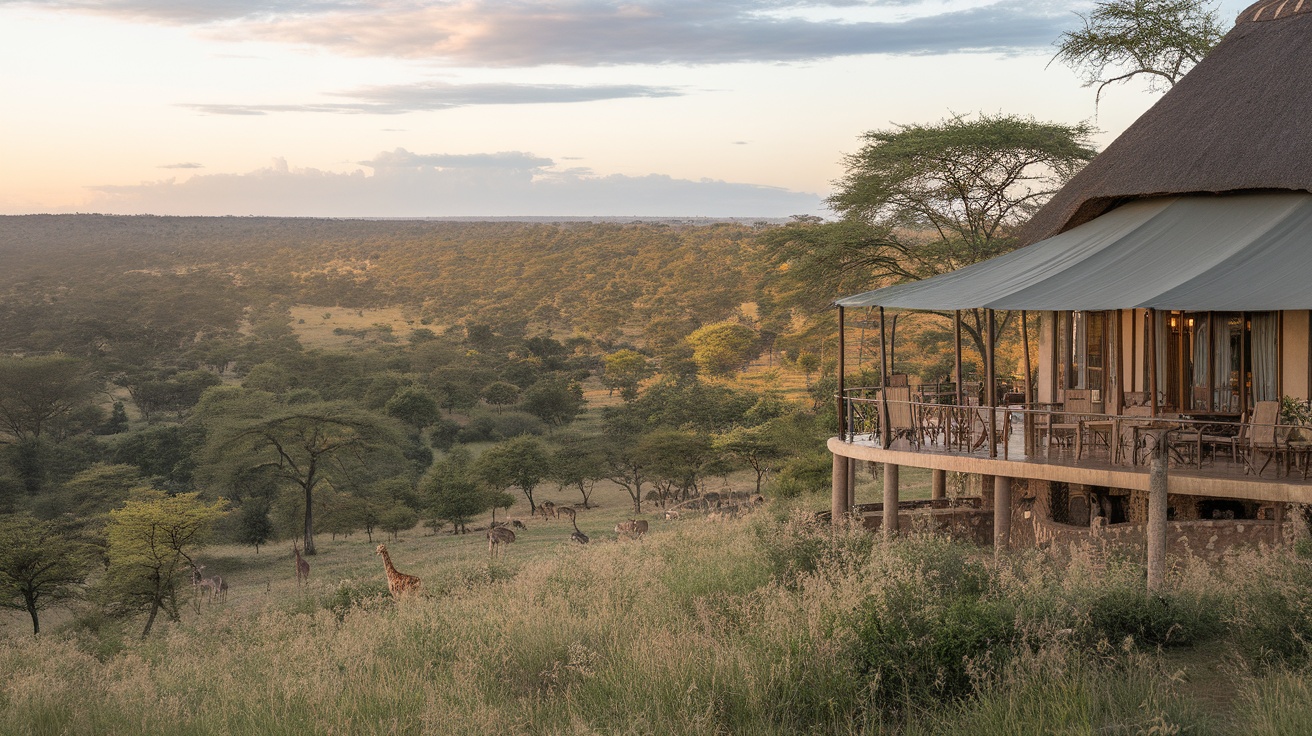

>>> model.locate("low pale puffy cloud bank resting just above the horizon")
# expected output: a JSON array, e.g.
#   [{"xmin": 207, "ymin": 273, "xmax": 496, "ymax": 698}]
[{"xmin": 82, "ymin": 150, "xmax": 823, "ymax": 218}]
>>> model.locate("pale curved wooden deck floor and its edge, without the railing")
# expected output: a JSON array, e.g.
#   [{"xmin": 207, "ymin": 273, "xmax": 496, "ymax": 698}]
[{"xmin": 829, "ymin": 428, "xmax": 1312, "ymax": 504}]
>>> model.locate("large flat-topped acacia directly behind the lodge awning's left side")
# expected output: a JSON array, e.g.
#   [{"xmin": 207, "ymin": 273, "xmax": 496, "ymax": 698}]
[{"xmin": 761, "ymin": 114, "xmax": 1094, "ymax": 354}]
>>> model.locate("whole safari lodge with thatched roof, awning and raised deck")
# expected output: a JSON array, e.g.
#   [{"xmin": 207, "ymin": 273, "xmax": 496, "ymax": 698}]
[{"xmin": 829, "ymin": 0, "xmax": 1312, "ymax": 567}]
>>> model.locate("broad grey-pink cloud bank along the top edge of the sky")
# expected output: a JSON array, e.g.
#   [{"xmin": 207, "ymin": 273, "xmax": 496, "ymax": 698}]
[{"xmin": 15, "ymin": 0, "xmax": 1088, "ymax": 67}]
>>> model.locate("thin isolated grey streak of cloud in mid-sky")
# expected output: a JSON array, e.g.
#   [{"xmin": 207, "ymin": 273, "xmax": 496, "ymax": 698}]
[{"xmin": 182, "ymin": 83, "xmax": 681, "ymax": 115}]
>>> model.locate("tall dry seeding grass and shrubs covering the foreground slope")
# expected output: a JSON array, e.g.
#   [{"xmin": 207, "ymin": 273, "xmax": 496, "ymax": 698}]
[{"xmin": 0, "ymin": 513, "xmax": 1312, "ymax": 735}]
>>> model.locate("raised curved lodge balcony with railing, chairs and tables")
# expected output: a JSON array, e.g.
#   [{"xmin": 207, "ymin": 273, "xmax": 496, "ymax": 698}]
[{"xmin": 829, "ymin": 387, "xmax": 1312, "ymax": 504}]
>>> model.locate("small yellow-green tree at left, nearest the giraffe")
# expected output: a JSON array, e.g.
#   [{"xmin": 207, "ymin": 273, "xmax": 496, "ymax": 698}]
[{"xmin": 102, "ymin": 491, "xmax": 227, "ymax": 639}]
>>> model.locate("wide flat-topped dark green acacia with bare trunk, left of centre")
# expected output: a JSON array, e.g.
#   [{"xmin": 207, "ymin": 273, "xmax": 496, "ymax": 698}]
[{"xmin": 205, "ymin": 401, "xmax": 404, "ymax": 555}]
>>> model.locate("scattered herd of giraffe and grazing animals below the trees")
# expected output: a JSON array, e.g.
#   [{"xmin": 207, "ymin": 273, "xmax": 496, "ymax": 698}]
[{"xmin": 183, "ymin": 492, "xmax": 765, "ymax": 605}]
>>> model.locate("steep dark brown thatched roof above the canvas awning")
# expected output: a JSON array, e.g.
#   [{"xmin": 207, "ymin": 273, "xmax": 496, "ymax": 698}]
[{"xmin": 1021, "ymin": 0, "xmax": 1312, "ymax": 244}]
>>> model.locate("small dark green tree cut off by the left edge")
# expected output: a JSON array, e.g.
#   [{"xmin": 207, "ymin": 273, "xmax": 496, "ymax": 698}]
[{"xmin": 0, "ymin": 514, "xmax": 89, "ymax": 635}]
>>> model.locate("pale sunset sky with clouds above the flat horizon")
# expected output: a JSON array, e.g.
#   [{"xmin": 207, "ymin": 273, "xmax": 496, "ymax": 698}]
[{"xmin": 0, "ymin": 0, "xmax": 1245, "ymax": 218}]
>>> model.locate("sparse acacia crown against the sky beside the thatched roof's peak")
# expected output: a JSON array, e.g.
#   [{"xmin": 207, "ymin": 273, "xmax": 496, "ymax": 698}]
[{"xmin": 1054, "ymin": 0, "xmax": 1224, "ymax": 101}]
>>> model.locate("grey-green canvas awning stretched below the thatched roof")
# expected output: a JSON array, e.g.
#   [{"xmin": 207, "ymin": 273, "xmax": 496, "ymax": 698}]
[{"xmin": 834, "ymin": 192, "xmax": 1312, "ymax": 311}]
